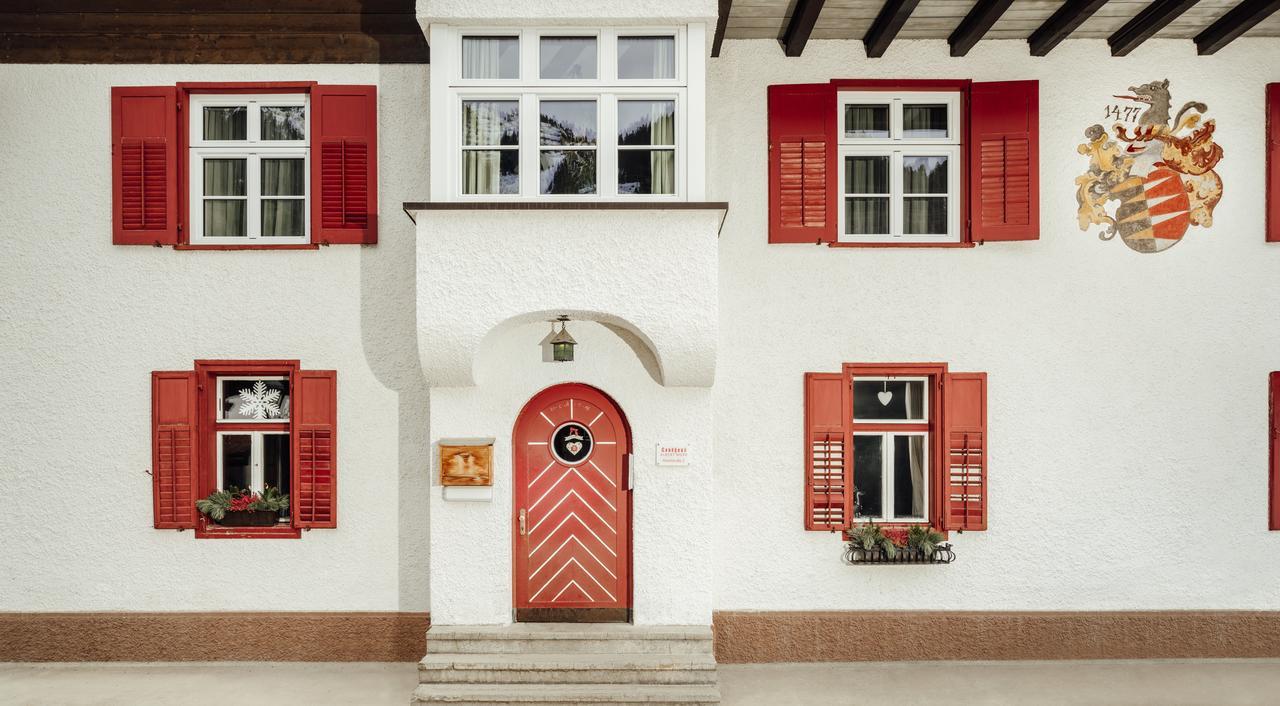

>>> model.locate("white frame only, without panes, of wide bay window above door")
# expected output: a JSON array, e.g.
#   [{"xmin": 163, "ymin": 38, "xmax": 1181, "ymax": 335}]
[{"xmin": 431, "ymin": 24, "xmax": 705, "ymax": 202}]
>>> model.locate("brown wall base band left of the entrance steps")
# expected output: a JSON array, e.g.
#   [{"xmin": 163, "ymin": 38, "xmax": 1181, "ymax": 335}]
[{"xmin": 0, "ymin": 613, "xmax": 430, "ymax": 661}]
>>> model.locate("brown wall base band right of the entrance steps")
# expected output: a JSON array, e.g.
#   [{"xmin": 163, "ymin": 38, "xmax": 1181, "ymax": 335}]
[{"xmin": 714, "ymin": 610, "xmax": 1280, "ymax": 664}]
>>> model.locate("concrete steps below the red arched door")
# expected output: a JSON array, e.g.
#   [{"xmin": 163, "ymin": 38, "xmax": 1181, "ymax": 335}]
[{"xmin": 412, "ymin": 623, "xmax": 719, "ymax": 706}]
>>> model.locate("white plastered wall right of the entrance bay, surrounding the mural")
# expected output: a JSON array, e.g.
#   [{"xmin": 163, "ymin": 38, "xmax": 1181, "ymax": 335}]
[{"xmin": 708, "ymin": 40, "xmax": 1280, "ymax": 610}]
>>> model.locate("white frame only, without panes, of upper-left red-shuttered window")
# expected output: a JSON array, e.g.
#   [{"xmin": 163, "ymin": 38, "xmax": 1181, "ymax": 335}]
[{"xmin": 187, "ymin": 93, "xmax": 311, "ymax": 246}]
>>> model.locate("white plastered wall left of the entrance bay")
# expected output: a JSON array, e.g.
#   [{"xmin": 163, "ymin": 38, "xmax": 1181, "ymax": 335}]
[{"xmin": 0, "ymin": 65, "xmax": 429, "ymax": 611}]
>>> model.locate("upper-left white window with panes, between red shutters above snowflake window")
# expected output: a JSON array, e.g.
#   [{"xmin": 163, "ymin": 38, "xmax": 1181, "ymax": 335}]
[{"xmin": 187, "ymin": 93, "xmax": 311, "ymax": 246}]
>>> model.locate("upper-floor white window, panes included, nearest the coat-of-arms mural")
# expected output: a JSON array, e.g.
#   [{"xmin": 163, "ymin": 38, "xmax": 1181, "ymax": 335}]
[{"xmin": 837, "ymin": 91, "xmax": 961, "ymax": 243}]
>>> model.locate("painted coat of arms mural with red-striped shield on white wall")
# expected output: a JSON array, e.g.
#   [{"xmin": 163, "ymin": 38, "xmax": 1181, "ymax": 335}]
[{"xmin": 1075, "ymin": 78, "xmax": 1222, "ymax": 252}]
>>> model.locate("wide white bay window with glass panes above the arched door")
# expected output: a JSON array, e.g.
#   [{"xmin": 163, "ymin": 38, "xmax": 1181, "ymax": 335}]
[{"xmin": 433, "ymin": 27, "xmax": 701, "ymax": 201}]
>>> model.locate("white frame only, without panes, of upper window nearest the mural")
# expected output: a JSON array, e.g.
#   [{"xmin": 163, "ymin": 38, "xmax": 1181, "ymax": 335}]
[{"xmin": 836, "ymin": 91, "xmax": 964, "ymax": 243}]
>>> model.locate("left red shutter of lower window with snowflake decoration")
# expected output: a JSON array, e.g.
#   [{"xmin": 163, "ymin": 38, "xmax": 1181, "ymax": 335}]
[{"xmin": 151, "ymin": 371, "xmax": 196, "ymax": 530}]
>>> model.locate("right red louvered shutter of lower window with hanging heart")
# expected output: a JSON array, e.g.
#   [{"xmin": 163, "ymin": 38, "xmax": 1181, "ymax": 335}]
[{"xmin": 942, "ymin": 372, "xmax": 987, "ymax": 530}]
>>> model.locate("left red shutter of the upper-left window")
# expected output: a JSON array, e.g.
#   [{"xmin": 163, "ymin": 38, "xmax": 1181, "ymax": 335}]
[{"xmin": 111, "ymin": 86, "xmax": 178, "ymax": 246}]
